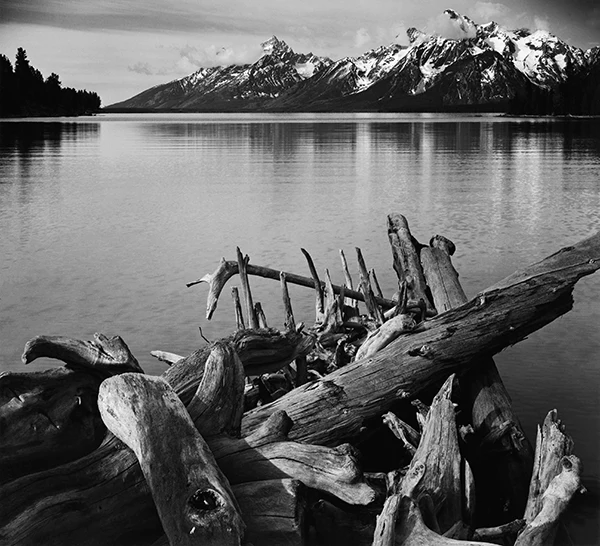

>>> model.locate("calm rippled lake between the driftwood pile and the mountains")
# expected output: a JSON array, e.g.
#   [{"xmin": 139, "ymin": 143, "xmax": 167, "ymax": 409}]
[{"xmin": 0, "ymin": 114, "xmax": 600, "ymax": 545}]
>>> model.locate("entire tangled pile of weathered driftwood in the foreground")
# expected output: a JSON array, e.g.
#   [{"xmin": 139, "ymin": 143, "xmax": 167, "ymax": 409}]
[{"xmin": 0, "ymin": 214, "xmax": 600, "ymax": 546}]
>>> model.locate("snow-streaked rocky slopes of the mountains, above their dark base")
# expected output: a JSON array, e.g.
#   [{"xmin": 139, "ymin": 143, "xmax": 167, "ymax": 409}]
[{"xmin": 110, "ymin": 9, "xmax": 600, "ymax": 109}]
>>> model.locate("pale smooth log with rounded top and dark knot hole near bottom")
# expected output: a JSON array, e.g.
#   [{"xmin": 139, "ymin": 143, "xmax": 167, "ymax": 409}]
[{"xmin": 98, "ymin": 374, "xmax": 245, "ymax": 546}]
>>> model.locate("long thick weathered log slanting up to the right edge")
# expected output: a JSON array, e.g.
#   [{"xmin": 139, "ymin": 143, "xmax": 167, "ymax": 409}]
[{"xmin": 242, "ymin": 233, "xmax": 600, "ymax": 445}]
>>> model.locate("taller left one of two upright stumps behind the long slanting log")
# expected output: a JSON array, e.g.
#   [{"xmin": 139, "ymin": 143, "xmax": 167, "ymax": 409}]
[{"xmin": 387, "ymin": 214, "xmax": 435, "ymax": 316}]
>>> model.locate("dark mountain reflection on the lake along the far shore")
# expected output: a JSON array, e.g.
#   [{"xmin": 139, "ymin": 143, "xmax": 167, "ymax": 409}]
[{"xmin": 139, "ymin": 120, "xmax": 600, "ymax": 161}]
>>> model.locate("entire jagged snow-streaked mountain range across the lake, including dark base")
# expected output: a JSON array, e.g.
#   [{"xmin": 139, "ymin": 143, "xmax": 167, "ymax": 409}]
[{"xmin": 106, "ymin": 10, "xmax": 600, "ymax": 115}]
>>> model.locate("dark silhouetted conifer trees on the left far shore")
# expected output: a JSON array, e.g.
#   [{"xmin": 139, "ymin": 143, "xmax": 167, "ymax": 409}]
[{"xmin": 0, "ymin": 47, "xmax": 101, "ymax": 117}]
